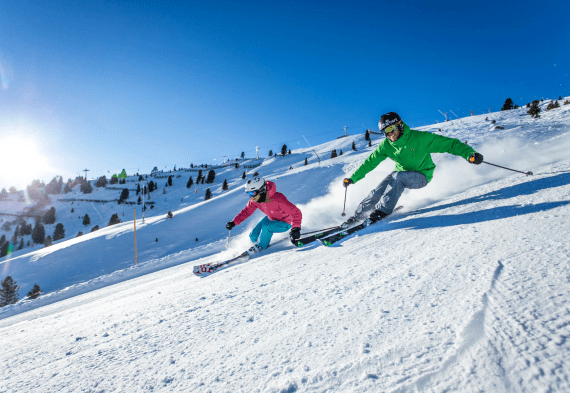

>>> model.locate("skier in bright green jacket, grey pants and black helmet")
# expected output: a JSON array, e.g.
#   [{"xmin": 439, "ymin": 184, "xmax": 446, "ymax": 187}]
[{"xmin": 342, "ymin": 112, "xmax": 483, "ymax": 228}]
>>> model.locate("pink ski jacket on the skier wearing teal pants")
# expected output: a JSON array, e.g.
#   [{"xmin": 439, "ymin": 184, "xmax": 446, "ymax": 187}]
[{"xmin": 234, "ymin": 181, "xmax": 303, "ymax": 228}]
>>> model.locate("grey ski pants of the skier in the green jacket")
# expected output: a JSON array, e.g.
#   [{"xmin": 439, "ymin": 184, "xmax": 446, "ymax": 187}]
[{"xmin": 354, "ymin": 171, "xmax": 428, "ymax": 220}]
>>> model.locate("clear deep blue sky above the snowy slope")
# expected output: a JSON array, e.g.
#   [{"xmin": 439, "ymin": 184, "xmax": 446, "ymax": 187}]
[{"xmin": 0, "ymin": 0, "xmax": 570, "ymax": 188}]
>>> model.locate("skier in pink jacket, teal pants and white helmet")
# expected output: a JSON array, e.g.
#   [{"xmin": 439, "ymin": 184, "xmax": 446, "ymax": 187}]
[{"xmin": 226, "ymin": 177, "xmax": 303, "ymax": 255}]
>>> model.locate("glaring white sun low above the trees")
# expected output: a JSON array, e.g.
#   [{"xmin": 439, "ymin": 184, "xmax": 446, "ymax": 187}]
[{"xmin": 0, "ymin": 134, "xmax": 51, "ymax": 190}]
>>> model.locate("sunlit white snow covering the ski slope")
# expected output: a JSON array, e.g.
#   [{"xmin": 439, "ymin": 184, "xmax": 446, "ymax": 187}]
[{"xmin": 0, "ymin": 101, "xmax": 570, "ymax": 392}]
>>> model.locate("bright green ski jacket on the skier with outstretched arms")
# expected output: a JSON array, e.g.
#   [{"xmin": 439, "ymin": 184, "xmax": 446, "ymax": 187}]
[{"xmin": 350, "ymin": 123, "xmax": 476, "ymax": 183}]
